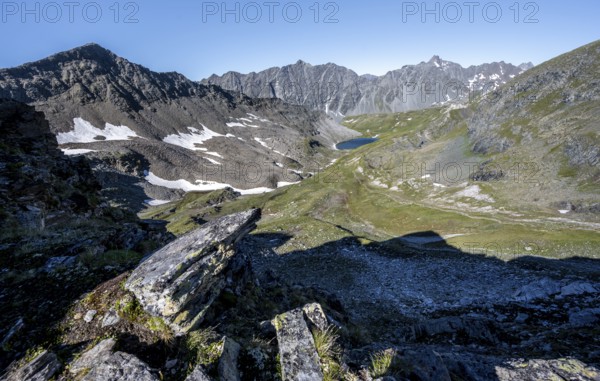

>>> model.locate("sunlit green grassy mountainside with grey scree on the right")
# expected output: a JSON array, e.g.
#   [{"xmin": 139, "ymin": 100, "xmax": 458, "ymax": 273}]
[{"xmin": 151, "ymin": 42, "xmax": 600, "ymax": 258}]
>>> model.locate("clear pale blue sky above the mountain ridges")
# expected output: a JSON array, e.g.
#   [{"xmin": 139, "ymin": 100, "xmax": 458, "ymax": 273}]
[{"xmin": 0, "ymin": 0, "xmax": 600, "ymax": 80}]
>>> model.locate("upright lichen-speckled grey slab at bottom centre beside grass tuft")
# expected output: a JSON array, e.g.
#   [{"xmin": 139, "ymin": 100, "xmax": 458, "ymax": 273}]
[{"xmin": 273, "ymin": 309, "xmax": 323, "ymax": 381}]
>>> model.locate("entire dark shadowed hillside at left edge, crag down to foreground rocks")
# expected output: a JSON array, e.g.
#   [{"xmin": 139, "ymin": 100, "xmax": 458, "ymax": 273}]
[{"xmin": 0, "ymin": 100, "xmax": 170, "ymax": 368}]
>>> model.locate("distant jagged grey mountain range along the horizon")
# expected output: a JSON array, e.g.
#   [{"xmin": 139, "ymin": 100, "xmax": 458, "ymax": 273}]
[{"xmin": 201, "ymin": 56, "xmax": 533, "ymax": 120}]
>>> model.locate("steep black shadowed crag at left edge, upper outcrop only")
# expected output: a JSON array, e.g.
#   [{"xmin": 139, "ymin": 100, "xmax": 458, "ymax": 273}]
[{"xmin": 0, "ymin": 100, "xmax": 100, "ymax": 232}]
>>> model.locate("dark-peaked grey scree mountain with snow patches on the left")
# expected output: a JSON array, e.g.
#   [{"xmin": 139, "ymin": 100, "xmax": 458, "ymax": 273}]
[{"xmin": 0, "ymin": 44, "xmax": 355, "ymax": 203}]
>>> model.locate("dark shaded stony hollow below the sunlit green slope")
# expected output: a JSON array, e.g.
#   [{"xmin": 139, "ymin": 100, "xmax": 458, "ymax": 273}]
[{"xmin": 241, "ymin": 227, "xmax": 600, "ymax": 380}]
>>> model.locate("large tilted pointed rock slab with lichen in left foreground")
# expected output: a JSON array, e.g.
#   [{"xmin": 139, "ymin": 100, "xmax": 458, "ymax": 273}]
[{"xmin": 125, "ymin": 209, "xmax": 260, "ymax": 333}]
